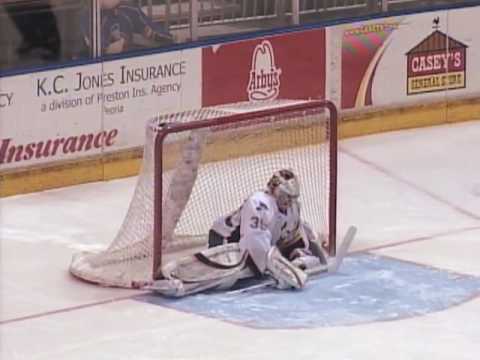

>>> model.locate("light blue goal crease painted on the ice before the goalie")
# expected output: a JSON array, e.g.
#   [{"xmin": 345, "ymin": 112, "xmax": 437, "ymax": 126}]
[{"xmin": 137, "ymin": 254, "xmax": 480, "ymax": 329}]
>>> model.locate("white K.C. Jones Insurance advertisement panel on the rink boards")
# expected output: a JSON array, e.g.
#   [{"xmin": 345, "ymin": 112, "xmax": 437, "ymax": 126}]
[{"xmin": 0, "ymin": 49, "xmax": 201, "ymax": 170}]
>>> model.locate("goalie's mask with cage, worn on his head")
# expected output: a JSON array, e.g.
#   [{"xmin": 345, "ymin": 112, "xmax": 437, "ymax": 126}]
[{"xmin": 267, "ymin": 169, "xmax": 300, "ymax": 210}]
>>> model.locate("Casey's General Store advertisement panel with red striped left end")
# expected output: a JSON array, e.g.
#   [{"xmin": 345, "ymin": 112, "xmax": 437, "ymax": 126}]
[{"xmin": 341, "ymin": 7, "xmax": 480, "ymax": 109}]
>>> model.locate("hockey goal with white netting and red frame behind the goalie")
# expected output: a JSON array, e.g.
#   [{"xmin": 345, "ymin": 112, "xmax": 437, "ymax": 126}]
[{"xmin": 70, "ymin": 100, "xmax": 337, "ymax": 287}]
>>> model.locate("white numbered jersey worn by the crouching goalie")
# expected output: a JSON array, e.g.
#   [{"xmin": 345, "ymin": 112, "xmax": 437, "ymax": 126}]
[{"xmin": 212, "ymin": 191, "xmax": 308, "ymax": 273}]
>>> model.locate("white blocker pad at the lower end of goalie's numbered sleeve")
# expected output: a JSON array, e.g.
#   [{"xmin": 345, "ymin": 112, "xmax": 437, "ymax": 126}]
[{"xmin": 266, "ymin": 247, "xmax": 308, "ymax": 289}]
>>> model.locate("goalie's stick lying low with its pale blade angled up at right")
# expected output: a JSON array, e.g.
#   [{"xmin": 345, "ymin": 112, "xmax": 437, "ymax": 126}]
[{"xmin": 227, "ymin": 226, "xmax": 357, "ymax": 295}]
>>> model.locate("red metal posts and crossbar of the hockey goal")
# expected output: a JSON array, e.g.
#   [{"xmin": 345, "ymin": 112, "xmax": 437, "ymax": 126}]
[{"xmin": 152, "ymin": 100, "xmax": 338, "ymax": 280}]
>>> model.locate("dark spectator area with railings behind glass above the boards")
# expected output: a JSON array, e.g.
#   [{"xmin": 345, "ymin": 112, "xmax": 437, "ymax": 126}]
[{"xmin": 0, "ymin": 0, "xmax": 480, "ymax": 75}]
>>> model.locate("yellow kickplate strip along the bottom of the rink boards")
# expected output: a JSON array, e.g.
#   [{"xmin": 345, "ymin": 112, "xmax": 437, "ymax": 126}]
[{"xmin": 0, "ymin": 98, "xmax": 480, "ymax": 197}]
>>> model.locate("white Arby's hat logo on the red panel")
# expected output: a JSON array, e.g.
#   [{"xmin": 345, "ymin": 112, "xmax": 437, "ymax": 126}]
[{"xmin": 247, "ymin": 40, "xmax": 282, "ymax": 101}]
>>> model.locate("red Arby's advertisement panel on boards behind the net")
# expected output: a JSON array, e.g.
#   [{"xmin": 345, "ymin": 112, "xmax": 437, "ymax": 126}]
[{"xmin": 202, "ymin": 29, "xmax": 325, "ymax": 106}]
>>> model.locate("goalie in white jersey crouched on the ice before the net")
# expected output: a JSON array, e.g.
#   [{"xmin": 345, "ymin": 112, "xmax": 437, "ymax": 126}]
[{"xmin": 145, "ymin": 169, "xmax": 336, "ymax": 297}]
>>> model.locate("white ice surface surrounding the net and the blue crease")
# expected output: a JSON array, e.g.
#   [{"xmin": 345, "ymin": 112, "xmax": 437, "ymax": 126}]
[{"xmin": 0, "ymin": 121, "xmax": 480, "ymax": 360}]
